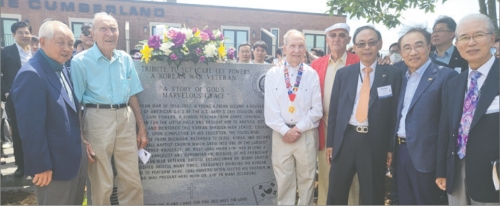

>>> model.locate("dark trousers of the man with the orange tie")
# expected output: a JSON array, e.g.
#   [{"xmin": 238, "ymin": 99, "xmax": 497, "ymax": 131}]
[{"xmin": 327, "ymin": 127, "xmax": 387, "ymax": 205}]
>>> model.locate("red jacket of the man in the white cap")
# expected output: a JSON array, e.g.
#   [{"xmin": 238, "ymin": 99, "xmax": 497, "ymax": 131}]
[{"xmin": 311, "ymin": 52, "xmax": 359, "ymax": 150}]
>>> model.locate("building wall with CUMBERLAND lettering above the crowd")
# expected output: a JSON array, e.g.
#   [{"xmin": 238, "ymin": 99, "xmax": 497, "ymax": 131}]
[{"xmin": 0, "ymin": 0, "xmax": 346, "ymax": 52}]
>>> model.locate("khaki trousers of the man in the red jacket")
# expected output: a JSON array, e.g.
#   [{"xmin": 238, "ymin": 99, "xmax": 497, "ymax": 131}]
[{"xmin": 317, "ymin": 123, "xmax": 359, "ymax": 205}]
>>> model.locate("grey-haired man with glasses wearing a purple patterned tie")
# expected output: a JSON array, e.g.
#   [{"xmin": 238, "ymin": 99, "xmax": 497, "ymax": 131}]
[{"xmin": 436, "ymin": 14, "xmax": 500, "ymax": 205}]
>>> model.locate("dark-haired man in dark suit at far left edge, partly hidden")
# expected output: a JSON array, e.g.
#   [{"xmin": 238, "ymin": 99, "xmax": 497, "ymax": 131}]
[{"xmin": 2, "ymin": 22, "xmax": 32, "ymax": 177}]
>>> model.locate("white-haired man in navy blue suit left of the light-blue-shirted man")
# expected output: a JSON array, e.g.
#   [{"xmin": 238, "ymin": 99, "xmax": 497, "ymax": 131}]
[{"xmin": 11, "ymin": 21, "xmax": 87, "ymax": 205}]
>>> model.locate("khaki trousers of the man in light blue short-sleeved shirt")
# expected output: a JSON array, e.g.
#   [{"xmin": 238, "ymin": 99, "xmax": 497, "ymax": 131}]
[{"xmin": 83, "ymin": 107, "xmax": 144, "ymax": 205}]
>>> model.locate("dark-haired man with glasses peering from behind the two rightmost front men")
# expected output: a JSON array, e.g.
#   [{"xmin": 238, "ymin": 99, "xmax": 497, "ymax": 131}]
[{"xmin": 430, "ymin": 16, "xmax": 468, "ymax": 73}]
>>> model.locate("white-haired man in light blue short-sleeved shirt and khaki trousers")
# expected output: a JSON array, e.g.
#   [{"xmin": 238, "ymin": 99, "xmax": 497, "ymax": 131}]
[{"xmin": 71, "ymin": 12, "xmax": 148, "ymax": 205}]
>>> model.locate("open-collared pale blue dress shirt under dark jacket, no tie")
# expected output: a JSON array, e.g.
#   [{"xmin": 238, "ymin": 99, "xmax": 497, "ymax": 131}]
[{"xmin": 398, "ymin": 60, "xmax": 431, "ymax": 137}]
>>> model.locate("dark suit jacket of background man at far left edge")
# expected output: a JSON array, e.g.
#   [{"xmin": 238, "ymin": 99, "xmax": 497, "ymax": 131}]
[{"xmin": 1, "ymin": 44, "xmax": 21, "ymax": 101}]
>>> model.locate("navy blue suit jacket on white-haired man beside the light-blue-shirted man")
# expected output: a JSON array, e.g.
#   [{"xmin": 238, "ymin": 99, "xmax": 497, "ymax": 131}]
[{"xmin": 12, "ymin": 52, "xmax": 82, "ymax": 180}]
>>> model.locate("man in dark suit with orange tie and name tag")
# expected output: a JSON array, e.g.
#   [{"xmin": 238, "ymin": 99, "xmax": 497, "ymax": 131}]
[{"xmin": 326, "ymin": 26, "xmax": 402, "ymax": 205}]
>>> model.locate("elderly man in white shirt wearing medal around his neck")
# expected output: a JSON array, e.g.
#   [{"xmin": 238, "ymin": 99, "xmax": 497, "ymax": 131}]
[{"xmin": 264, "ymin": 30, "xmax": 323, "ymax": 205}]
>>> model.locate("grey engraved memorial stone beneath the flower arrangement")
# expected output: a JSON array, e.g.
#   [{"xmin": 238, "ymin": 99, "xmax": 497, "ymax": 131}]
[{"xmin": 136, "ymin": 61, "xmax": 277, "ymax": 205}]
